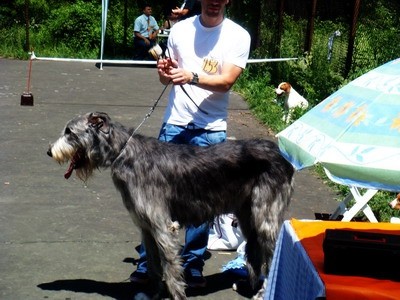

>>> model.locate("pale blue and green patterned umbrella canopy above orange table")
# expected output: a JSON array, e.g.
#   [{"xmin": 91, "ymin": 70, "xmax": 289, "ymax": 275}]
[{"xmin": 277, "ymin": 58, "xmax": 400, "ymax": 192}]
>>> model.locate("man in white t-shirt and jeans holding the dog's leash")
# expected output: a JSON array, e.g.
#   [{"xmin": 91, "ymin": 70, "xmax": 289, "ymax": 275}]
[{"xmin": 130, "ymin": 0, "xmax": 250, "ymax": 287}]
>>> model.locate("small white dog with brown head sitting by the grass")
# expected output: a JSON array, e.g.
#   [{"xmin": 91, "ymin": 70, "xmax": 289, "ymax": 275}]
[{"xmin": 275, "ymin": 82, "xmax": 308, "ymax": 123}]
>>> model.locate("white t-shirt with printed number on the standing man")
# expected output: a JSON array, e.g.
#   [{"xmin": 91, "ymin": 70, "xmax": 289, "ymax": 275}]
[{"xmin": 164, "ymin": 16, "xmax": 250, "ymax": 131}]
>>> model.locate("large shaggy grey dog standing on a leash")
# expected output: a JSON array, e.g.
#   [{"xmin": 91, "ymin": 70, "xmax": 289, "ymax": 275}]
[{"xmin": 48, "ymin": 112, "xmax": 294, "ymax": 299}]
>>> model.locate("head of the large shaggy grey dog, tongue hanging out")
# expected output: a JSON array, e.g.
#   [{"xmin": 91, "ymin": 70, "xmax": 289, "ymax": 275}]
[{"xmin": 47, "ymin": 112, "xmax": 110, "ymax": 181}]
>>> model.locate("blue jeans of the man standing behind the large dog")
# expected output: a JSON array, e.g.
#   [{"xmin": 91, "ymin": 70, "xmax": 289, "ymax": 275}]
[{"xmin": 137, "ymin": 124, "xmax": 226, "ymax": 273}]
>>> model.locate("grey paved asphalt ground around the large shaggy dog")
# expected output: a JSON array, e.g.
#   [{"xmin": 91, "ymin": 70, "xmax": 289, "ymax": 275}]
[{"xmin": 0, "ymin": 59, "xmax": 335, "ymax": 299}]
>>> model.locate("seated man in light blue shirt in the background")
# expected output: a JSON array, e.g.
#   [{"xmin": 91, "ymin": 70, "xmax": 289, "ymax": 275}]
[{"xmin": 133, "ymin": 4, "xmax": 159, "ymax": 60}]
